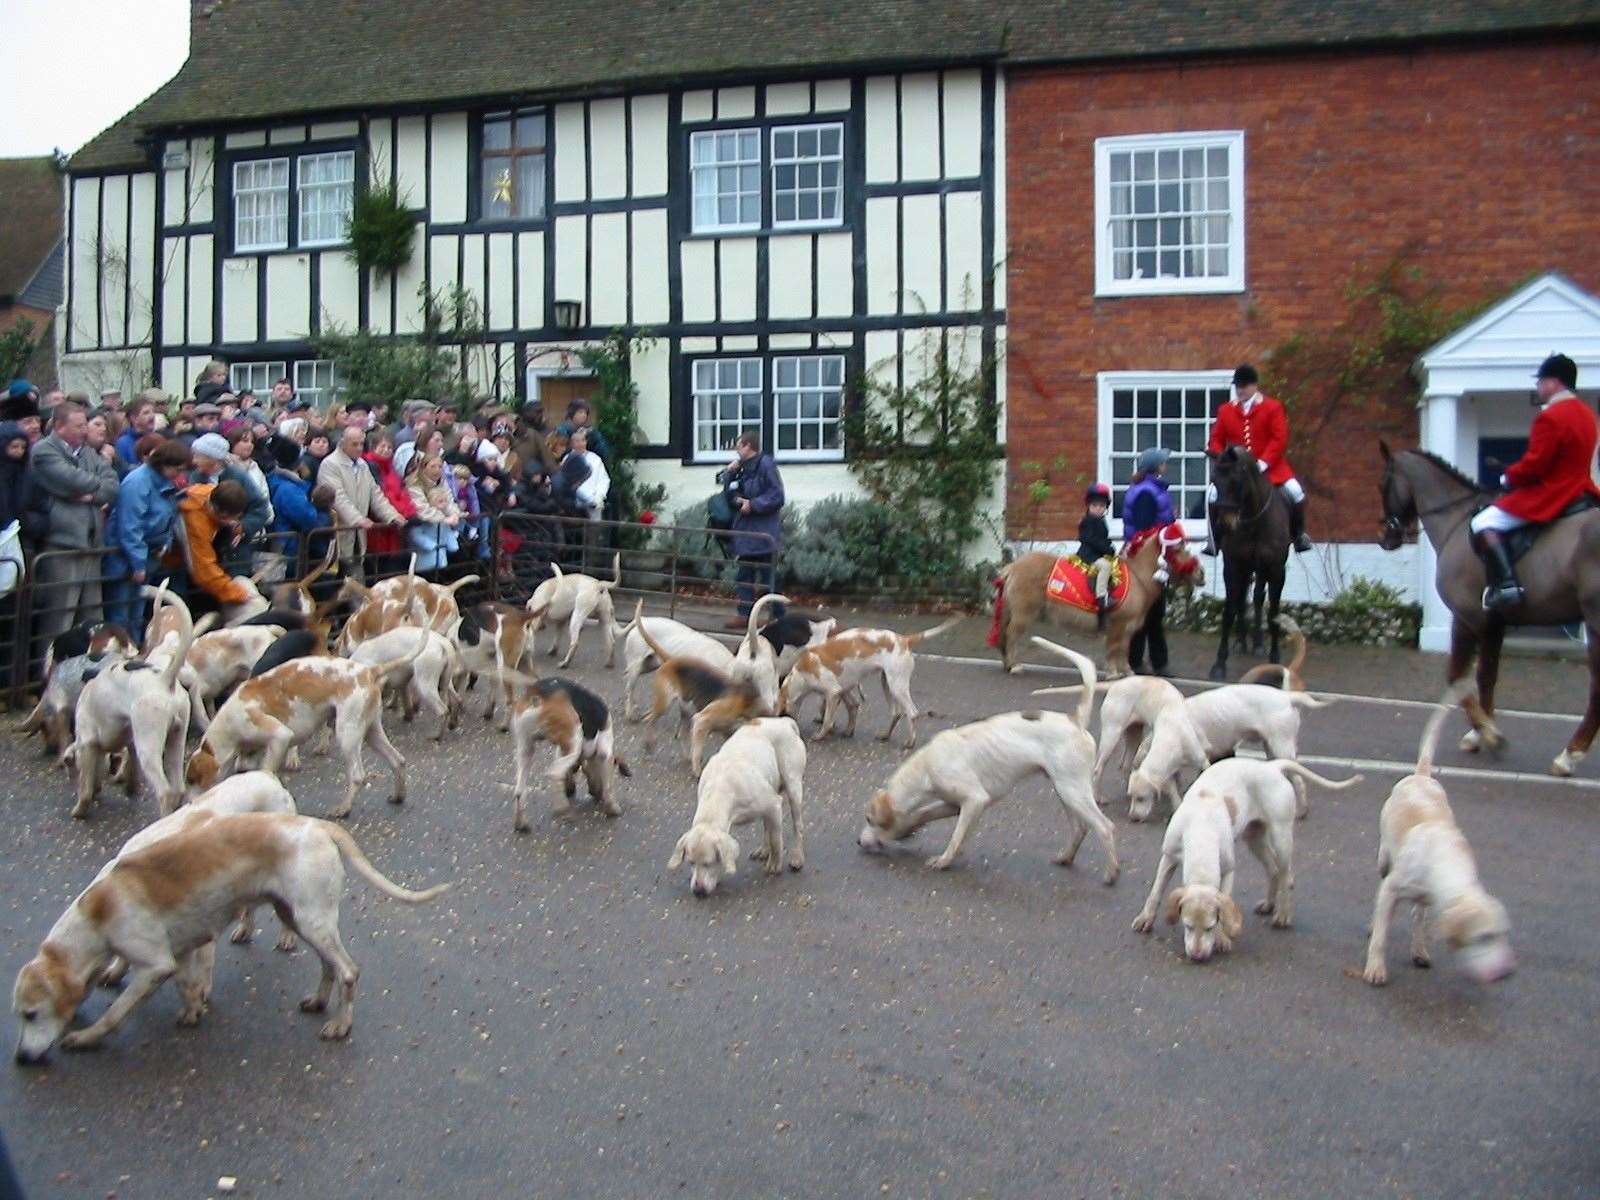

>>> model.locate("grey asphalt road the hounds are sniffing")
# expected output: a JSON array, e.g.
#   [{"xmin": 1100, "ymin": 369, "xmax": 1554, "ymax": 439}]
[{"xmin": 0, "ymin": 634, "xmax": 1600, "ymax": 1198}]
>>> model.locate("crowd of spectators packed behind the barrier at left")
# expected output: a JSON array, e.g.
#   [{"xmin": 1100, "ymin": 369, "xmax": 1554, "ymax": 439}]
[{"xmin": 0, "ymin": 362, "xmax": 610, "ymax": 658}]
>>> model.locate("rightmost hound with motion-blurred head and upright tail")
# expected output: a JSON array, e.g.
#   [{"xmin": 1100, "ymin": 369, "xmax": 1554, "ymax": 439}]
[{"xmin": 1362, "ymin": 685, "xmax": 1517, "ymax": 987}]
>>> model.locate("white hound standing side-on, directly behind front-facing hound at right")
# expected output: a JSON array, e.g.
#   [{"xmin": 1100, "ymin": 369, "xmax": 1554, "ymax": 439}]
[{"xmin": 1128, "ymin": 683, "xmax": 1333, "ymax": 821}]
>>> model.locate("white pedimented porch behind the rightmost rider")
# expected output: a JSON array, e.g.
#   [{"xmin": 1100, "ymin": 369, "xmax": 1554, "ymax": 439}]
[{"xmin": 1414, "ymin": 272, "xmax": 1600, "ymax": 653}]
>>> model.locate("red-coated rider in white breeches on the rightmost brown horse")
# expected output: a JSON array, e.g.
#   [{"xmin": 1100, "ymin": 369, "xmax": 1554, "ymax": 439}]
[{"xmin": 1470, "ymin": 354, "xmax": 1600, "ymax": 613}]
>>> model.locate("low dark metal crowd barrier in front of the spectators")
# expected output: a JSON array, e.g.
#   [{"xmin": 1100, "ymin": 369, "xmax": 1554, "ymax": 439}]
[{"xmin": 0, "ymin": 510, "xmax": 782, "ymax": 710}]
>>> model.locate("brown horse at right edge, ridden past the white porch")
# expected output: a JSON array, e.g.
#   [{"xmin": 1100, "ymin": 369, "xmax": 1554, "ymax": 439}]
[{"xmin": 1379, "ymin": 443, "xmax": 1600, "ymax": 776}]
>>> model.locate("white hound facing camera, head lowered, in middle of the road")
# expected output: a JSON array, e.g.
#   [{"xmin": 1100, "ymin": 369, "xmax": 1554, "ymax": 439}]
[{"xmin": 667, "ymin": 717, "xmax": 806, "ymax": 899}]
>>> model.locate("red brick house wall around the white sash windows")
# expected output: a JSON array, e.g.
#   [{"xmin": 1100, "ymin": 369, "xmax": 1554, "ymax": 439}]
[{"xmin": 1006, "ymin": 43, "xmax": 1600, "ymax": 541}]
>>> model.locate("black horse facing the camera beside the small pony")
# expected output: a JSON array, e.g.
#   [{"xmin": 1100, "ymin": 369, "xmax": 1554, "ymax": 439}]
[{"xmin": 1211, "ymin": 446, "xmax": 1290, "ymax": 680}]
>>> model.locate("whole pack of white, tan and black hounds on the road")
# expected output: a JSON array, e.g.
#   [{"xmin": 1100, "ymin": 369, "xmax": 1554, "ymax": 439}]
[{"xmin": 13, "ymin": 560, "xmax": 1514, "ymax": 1062}]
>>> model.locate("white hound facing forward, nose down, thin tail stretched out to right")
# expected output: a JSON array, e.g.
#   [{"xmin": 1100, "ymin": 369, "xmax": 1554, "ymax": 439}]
[{"xmin": 1133, "ymin": 758, "xmax": 1362, "ymax": 963}]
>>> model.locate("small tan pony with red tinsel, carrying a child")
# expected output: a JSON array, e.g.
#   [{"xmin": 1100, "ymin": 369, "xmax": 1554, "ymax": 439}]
[{"xmin": 990, "ymin": 525, "xmax": 1205, "ymax": 678}]
